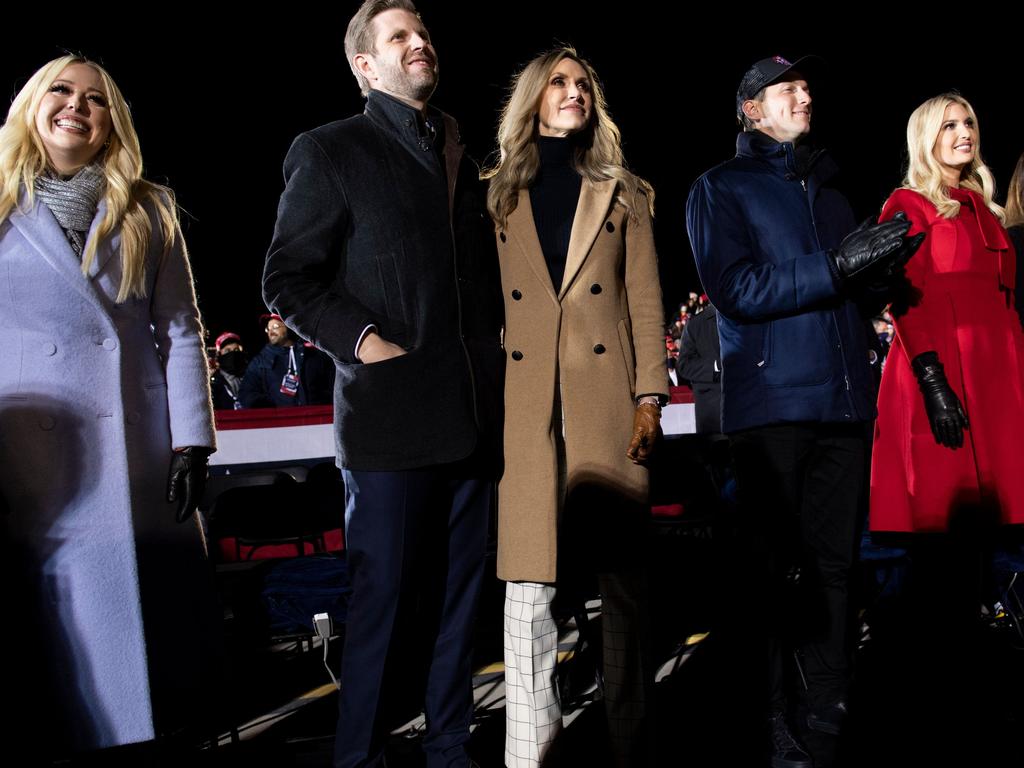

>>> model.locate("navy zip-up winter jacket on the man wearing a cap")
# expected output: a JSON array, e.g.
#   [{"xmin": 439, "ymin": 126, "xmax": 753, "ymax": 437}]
[{"xmin": 686, "ymin": 131, "xmax": 874, "ymax": 432}]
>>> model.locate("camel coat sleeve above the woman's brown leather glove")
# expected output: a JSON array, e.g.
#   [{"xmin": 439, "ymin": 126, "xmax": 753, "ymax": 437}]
[{"xmin": 626, "ymin": 195, "xmax": 669, "ymax": 401}]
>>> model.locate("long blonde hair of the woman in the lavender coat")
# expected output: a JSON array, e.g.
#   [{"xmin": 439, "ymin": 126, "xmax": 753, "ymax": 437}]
[{"xmin": 0, "ymin": 55, "xmax": 178, "ymax": 303}]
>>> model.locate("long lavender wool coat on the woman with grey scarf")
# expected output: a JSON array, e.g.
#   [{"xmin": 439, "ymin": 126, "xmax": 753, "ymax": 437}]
[{"xmin": 0, "ymin": 192, "xmax": 214, "ymax": 750}]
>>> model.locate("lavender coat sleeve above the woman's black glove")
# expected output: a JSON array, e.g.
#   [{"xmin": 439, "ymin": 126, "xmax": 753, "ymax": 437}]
[{"xmin": 150, "ymin": 200, "xmax": 217, "ymax": 449}]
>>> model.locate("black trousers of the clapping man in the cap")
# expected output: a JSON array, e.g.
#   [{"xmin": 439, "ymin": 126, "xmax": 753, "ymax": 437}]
[{"xmin": 720, "ymin": 423, "xmax": 868, "ymax": 709}]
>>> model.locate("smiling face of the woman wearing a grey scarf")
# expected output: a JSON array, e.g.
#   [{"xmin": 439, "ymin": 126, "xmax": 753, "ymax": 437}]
[{"xmin": 36, "ymin": 63, "xmax": 111, "ymax": 175}]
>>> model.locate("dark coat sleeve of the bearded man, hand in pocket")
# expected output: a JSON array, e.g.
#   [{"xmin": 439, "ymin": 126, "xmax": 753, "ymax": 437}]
[{"xmin": 263, "ymin": 134, "xmax": 379, "ymax": 362}]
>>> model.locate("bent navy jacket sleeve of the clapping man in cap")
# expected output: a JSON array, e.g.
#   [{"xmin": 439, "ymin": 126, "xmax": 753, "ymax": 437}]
[{"xmin": 686, "ymin": 174, "xmax": 838, "ymax": 322}]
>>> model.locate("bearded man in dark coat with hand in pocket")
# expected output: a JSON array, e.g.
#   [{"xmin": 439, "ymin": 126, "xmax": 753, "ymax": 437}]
[{"xmin": 263, "ymin": 0, "xmax": 504, "ymax": 768}]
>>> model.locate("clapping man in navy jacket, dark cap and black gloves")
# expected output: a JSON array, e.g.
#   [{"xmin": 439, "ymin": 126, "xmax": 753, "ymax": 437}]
[{"xmin": 686, "ymin": 56, "xmax": 915, "ymax": 768}]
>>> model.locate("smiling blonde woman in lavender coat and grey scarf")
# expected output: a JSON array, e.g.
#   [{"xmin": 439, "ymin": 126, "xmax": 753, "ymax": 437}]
[{"xmin": 0, "ymin": 55, "xmax": 214, "ymax": 761}]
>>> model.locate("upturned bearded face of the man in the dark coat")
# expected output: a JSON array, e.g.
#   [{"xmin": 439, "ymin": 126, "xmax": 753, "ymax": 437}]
[{"xmin": 353, "ymin": 8, "xmax": 437, "ymax": 110}]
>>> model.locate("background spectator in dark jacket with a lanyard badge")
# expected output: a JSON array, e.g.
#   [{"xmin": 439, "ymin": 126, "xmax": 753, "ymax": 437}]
[{"xmin": 239, "ymin": 314, "xmax": 334, "ymax": 408}]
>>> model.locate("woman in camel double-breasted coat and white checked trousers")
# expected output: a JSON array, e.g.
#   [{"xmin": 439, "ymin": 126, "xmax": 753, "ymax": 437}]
[{"xmin": 483, "ymin": 48, "xmax": 668, "ymax": 768}]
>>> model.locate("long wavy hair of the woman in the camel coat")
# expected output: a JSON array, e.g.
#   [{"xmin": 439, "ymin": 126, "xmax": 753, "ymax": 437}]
[{"xmin": 480, "ymin": 47, "xmax": 654, "ymax": 227}]
